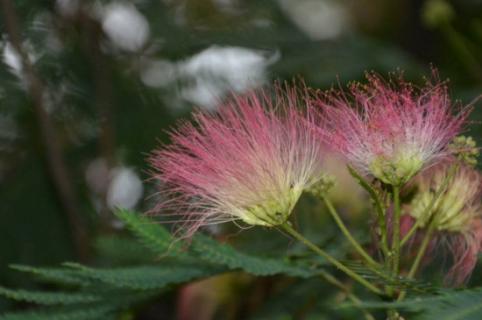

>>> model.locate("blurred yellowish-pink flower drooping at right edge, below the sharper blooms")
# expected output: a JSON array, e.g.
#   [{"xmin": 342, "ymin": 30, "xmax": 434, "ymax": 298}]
[{"xmin": 402, "ymin": 163, "xmax": 482, "ymax": 284}]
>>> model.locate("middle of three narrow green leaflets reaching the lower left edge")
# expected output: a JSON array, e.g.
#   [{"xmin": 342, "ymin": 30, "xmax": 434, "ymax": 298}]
[{"xmin": 0, "ymin": 287, "xmax": 100, "ymax": 305}]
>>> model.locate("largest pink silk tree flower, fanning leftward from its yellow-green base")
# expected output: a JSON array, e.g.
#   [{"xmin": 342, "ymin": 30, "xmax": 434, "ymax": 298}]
[{"xmin": 150, "ymin": 87, "xmax": 323, "ymax": 233}]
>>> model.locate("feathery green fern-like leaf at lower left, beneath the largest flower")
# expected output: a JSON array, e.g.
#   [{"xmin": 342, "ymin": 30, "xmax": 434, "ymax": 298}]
[{"xmin": 0, "ymin": 210, "xmax": 328, "ymax": 320}]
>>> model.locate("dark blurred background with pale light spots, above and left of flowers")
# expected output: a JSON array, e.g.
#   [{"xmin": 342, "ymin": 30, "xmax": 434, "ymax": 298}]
[{"xmin": 0, "ymin": 0, "xmax": 482, "ymax": 318}]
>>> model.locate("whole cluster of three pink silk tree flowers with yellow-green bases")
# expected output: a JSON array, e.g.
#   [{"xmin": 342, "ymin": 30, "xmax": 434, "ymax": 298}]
[{"xmin": 151, "ymin": 73, "xmax": 482, "ymax": 283}]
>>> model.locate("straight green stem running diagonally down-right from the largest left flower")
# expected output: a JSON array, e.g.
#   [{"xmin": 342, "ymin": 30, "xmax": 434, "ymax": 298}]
[{"xmin": 281, "ymin": 222, "xmax": 383, "ymax": 295}]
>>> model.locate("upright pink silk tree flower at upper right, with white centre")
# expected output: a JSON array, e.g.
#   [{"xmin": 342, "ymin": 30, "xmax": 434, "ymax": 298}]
[{"xmin": 312, "ymin": 73, "xmax": 471, "ymax": 186}]
